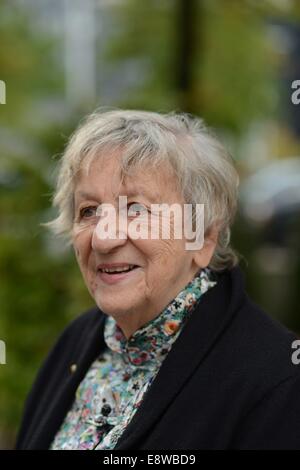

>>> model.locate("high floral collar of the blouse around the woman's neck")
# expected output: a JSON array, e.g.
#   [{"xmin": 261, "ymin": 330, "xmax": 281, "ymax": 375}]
[{"xmin": 104, "ymin": 268, "xmax": 216, "ymax": 368}]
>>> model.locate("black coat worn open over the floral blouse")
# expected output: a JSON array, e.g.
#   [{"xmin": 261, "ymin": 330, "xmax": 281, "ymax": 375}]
[{"xmin": 17, "ymin": 267, "xmax": 300, "ymax": 450}]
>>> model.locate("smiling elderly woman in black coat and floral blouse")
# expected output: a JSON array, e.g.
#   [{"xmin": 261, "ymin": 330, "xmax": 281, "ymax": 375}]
[{"xmin": 17, "ymin": 110, "xmax": 300, "ymax": 450}]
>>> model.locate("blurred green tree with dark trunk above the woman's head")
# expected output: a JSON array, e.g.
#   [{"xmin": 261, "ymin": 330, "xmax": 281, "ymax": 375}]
[{"xmin": 107, "ymin": 0, "xmax": 276, "ymax": 133}]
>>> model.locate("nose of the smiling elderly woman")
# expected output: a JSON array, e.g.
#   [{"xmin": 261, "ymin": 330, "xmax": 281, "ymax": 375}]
[{"xmin": 92, "ymin": 209, "xmax": 128, "ymax": 253}]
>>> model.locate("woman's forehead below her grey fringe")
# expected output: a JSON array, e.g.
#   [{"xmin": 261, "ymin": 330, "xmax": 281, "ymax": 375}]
[{"xmin": 75, "ymin": 157, "xmax": 180, "ymax": 202}]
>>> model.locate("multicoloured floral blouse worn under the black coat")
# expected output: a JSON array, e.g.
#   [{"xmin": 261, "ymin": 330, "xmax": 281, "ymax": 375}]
[{"xmin": 50, "ymin": 268, "xmax": 216, "ymax": 450}]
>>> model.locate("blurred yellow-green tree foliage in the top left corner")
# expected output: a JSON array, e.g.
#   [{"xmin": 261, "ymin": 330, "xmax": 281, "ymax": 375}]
[{"xmin": 0, "ymin": 0, "xmax": 62, "ymax": 130}]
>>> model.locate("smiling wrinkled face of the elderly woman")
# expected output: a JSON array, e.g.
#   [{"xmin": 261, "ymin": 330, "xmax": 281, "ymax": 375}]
[{"xmin": 72, "ymin": 154, "xmax": 214, "ymax": 338}]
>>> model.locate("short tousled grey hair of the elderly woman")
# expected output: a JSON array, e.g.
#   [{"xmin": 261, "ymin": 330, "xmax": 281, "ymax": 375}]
[{"xmin": 44, "ymin": 109, "xmax": 239, "ymax": 271}]
